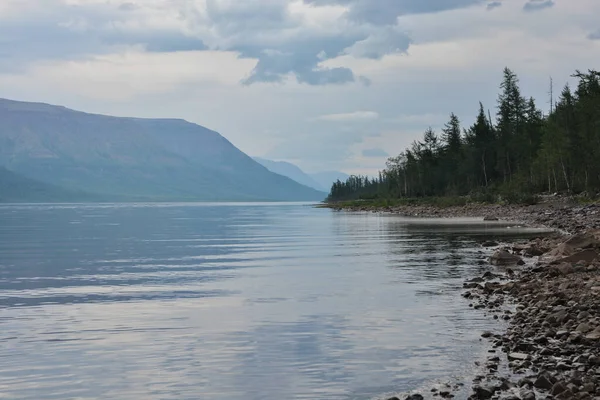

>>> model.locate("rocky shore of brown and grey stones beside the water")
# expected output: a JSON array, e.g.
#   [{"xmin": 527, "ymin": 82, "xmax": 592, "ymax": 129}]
[{"xmin": 338, "ymin": 198, "xmax": 600, "ymax": 400}]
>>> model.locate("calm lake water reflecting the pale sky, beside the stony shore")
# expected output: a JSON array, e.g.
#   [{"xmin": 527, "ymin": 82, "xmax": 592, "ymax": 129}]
[{"xmin": 0, "ymin": 204, "xmax": 548, "ymax": 400}]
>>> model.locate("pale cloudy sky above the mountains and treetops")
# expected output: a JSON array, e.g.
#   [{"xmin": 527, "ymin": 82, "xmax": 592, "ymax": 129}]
[{"xmin": 0, "ymin": 0, "xmax": 600, "ymax": 174}]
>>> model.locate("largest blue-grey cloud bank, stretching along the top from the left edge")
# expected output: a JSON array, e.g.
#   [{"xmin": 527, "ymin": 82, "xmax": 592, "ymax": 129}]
[{"xmin": 0, "ymin": 0, "xmax": 496, "ymax": 86}]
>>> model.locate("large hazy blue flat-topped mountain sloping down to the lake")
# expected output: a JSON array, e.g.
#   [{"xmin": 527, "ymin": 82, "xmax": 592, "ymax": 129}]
[{"xmin": 0, "ymin": 99, "xmax": 325, "ymax": 201}]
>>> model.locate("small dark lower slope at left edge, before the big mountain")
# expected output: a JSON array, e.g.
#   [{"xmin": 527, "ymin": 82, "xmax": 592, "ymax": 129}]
[{"xmin": 0, "ymin": 167, "xmax": 96, "ymax": 203}]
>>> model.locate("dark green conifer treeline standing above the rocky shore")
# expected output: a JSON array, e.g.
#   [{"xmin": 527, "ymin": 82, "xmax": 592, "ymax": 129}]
[{"xmin": 328, "ymin": 68, "xmax": 600, "ymax": 201}]
